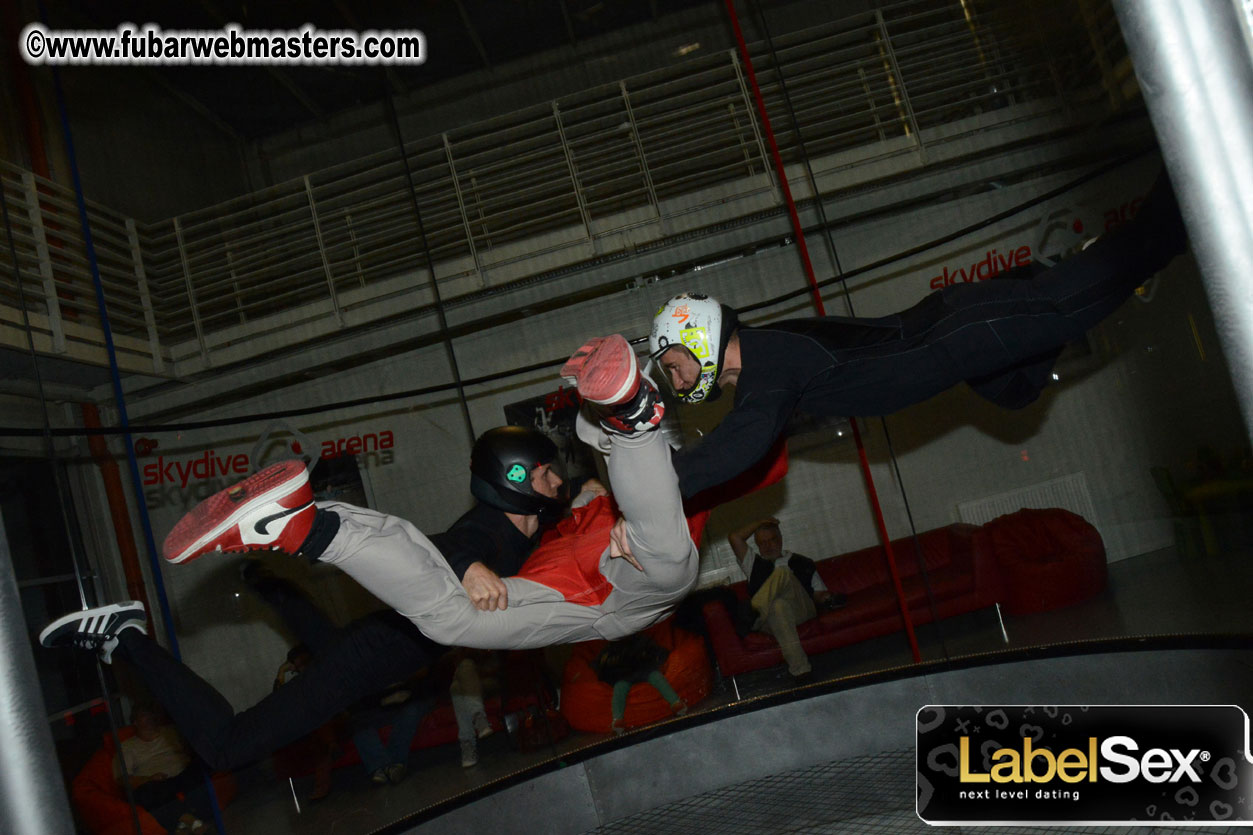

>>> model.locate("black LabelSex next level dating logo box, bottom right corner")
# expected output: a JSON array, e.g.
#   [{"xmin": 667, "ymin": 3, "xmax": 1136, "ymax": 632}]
[{"xmin": 917, "ymin": 705, "xmax": 1253, "ymax": 826}]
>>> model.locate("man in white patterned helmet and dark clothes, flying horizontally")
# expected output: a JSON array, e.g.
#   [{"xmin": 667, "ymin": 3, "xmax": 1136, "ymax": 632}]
[{"xmin": 649, "ymin": 174, "xmax": 1188, "ymax": 496}]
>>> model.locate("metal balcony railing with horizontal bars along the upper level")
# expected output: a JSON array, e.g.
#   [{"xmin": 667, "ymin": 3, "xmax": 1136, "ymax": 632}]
[{"xmin": 0, "ymin": 0, "xmax": 1125, "ymax": 374}]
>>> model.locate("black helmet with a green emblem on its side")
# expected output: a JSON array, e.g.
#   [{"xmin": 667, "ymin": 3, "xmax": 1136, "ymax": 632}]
[{"xmin": 470, "ymin": 426, "xmax": 564, "ymax": 515}]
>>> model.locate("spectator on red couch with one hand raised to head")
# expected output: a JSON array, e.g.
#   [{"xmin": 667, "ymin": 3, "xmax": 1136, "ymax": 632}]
[{"xmin": 727, "ymin": 517, "xmax": 848, "ymax": 678}]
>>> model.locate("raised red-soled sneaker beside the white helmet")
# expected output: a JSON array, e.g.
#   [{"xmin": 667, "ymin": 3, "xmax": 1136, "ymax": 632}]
[{"xmin": 561, "ymin": 333, "xmax": 665, "ymax": 435}]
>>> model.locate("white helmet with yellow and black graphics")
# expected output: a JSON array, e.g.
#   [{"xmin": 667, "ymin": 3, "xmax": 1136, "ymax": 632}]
[{"xmin": 648, "ymin": 293, "xmax": 739, "ymax": 402}]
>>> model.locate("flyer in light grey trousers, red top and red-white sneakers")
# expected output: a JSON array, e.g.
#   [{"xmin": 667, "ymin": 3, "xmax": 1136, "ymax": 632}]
[{"xmin": 256, "ymin": 335, "xmax": 761, "ymax": 649}]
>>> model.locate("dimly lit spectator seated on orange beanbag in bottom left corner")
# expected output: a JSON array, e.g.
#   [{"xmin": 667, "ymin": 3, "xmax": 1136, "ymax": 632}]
[{"xmin": 113, "ymin": 703, "xmax": 213, "ymax": 835}]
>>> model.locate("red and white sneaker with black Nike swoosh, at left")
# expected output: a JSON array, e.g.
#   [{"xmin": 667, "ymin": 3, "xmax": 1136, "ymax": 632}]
[{"xmin": 162, "ymin": 459, "xmax": 317, "ymax": 563}]
